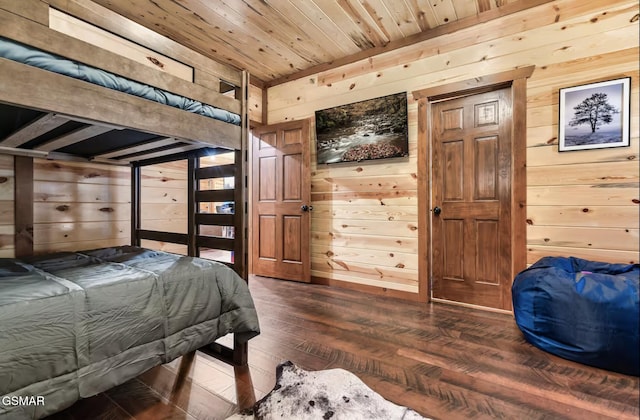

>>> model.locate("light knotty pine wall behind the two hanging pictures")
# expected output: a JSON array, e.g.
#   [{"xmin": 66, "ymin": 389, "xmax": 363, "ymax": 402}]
[{"xmin": 268, "ymin": 0, "xmax": 639, "ymax": 292}]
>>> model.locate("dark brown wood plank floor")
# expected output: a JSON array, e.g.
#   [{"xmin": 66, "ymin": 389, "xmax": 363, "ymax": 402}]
[{"xmin": 51, "ymin": 278, "xmax": 640, "ymax": 420}]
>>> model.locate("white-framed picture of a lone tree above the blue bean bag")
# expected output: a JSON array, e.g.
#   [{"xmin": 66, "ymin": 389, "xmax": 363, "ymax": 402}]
[{"xmin": 558, "ymin": 77, "xmax": 631, "ymax": 152}]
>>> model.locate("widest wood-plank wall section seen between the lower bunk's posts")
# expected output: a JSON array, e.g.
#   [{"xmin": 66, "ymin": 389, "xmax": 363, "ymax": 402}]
[{"xmin": 33, "ymin": 159, "xmax": 131, "ymax": 254}]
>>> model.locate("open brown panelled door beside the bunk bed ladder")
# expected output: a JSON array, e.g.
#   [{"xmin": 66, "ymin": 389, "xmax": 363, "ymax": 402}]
[{"xmin": 249, "ymin": 120, "xmax": 311, "ymax": 282}]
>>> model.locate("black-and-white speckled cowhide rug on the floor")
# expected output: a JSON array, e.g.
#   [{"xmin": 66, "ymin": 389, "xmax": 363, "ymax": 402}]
[{"xmin": 227, "ymin": 362, "xmax": 424, "ymax": 420}]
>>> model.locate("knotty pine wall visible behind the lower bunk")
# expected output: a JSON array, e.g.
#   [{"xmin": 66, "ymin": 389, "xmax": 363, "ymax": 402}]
[{"xmin": 0, "ymin": 155, "xmax": 198, "ymax": 258}]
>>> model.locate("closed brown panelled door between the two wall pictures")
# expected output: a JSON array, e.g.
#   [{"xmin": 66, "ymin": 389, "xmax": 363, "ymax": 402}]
[{"xmin": 431, "ymin": 88, "xmax": 513, "ymax": 310}]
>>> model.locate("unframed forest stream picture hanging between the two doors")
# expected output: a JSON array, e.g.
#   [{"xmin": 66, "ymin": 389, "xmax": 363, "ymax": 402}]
[{"xmin": 315, "ymin": 92, "xmax": 409, "ymax": 164}]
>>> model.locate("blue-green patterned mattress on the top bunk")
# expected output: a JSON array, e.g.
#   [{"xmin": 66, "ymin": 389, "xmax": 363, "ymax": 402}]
[{"xmin": 0, "ymin": 37, "xmax": 241, "ymax": 125}]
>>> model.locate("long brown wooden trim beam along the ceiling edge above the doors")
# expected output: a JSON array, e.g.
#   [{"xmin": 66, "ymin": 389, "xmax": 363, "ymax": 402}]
[{"xmin": 265, "ymin": 0, "xmax": 555, "ymax": 88}]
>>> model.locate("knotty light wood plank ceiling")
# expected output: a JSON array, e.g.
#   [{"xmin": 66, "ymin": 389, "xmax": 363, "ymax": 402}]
[{"xmin": 93, "ymin": 0, "xmax": 546, "ymax": 86}]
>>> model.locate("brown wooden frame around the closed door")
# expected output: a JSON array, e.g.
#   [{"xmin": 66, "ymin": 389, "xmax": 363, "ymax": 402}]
[{"xmin": 413, "ymin": 66, "xmax": 535, "ymax": 306}]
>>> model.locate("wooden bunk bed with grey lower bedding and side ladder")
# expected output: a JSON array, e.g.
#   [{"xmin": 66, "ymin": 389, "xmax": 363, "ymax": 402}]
[{"xmin": 0, "ymin": 0, "xmax": 259, "ymax": 418}]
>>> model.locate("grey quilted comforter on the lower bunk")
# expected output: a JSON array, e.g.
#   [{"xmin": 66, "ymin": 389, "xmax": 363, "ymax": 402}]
[{"xmin": 0, "ymin": 247, "xmax": 259, "ymax": 419}]
